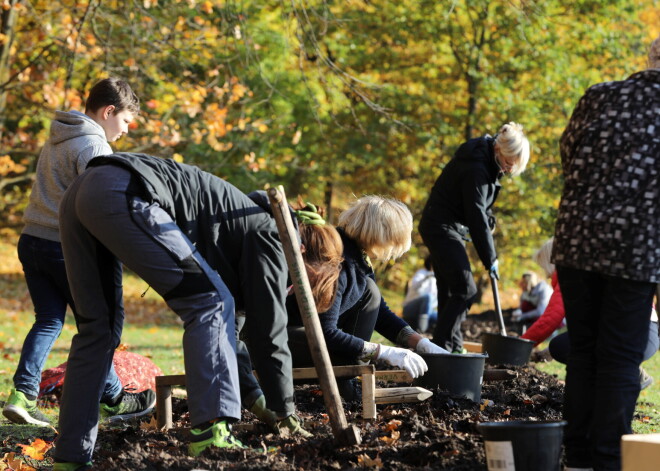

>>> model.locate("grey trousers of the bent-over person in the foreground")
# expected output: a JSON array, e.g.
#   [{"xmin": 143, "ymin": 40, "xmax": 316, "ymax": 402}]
[{"xmin": 55, "ymin": 165, "xmax": 241, "ymax": 462}]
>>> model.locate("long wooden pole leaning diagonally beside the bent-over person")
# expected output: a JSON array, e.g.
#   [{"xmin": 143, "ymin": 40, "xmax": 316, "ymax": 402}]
[{"xmin": 268, "ymin": 187, "xmax": 362, "ymax": 445}]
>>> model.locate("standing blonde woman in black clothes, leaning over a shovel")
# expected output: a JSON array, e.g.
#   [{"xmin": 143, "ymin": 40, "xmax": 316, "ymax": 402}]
[{"xmin": 419, "ymin": 123, "xmax": 530, "ymax": 352}]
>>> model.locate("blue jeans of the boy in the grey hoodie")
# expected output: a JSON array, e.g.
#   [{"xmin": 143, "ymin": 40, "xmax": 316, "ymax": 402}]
[{"xmin": 14, "ymin": 234, "xmax": 122, "ymax": 400}]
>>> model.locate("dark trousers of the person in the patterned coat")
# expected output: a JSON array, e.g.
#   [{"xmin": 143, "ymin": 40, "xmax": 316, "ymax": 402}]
[{"xmin": 557, "ymin": 266, "xmax": 656, "ymax": 471}]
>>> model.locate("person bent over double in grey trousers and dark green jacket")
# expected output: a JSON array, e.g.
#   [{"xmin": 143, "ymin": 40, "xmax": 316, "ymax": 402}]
[{"xmin": 55, "ymin": 153, "xmax": 309, "ymax": 469}]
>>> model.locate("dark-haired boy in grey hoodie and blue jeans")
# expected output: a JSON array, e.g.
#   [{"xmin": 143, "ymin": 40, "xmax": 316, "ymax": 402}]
[{"xmin": 2, "ymin": 78, "xmax": 155, "ymax": 426}]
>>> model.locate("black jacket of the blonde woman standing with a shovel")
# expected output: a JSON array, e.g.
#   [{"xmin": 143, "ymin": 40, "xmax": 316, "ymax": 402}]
[{"xmin": 419, "ymin": 135, "xmax": 502, "ymax": 268}]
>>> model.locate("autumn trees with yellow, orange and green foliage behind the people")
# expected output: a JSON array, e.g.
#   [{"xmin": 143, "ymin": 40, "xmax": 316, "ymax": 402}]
[{"xmin": 0, "ymin": 0, "xmax": 660, "ymax": 296}]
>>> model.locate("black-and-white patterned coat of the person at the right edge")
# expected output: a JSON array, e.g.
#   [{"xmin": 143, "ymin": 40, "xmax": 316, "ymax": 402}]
[{"xmin": 553, "ymin": 69, "xmax": 660, "ymax": 283}]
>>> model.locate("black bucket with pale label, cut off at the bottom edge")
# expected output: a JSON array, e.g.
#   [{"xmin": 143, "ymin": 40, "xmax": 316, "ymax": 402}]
[{"xmin": 477, "ymin": 420, "xmax": 566, "ymax": 471}]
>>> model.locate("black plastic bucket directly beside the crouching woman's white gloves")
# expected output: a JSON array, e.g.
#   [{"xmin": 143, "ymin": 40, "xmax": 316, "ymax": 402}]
[{"xmin": 413, "ymin": 353, "xmax": 488, "ymax": 402}]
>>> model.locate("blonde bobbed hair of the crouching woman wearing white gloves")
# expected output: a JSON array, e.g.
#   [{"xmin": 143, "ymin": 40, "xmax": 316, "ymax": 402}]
[{"xmin": 338, "ymin": 195, "xmax": 413, "ymax": 260}]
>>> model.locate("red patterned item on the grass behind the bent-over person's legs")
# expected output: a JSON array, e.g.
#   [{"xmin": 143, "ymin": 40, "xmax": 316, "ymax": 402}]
[{"xmin": 39, "ymin": 350, "xmax": 163, "ymax": 397}]
